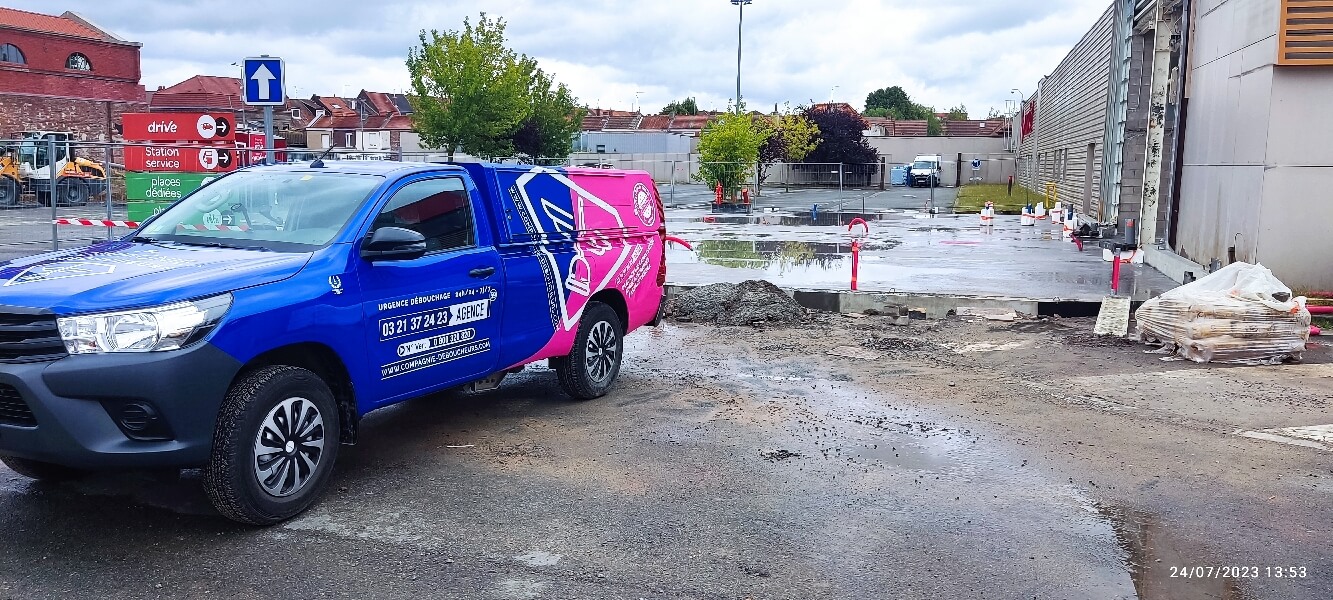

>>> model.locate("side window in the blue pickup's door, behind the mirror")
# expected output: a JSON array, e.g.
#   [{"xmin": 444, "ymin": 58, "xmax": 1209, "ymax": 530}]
[{"xmin": 373, "ymin": 177, "xmax": 476, "ymax": 252}]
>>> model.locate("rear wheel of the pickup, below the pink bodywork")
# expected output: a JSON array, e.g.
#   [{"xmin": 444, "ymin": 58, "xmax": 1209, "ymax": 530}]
[{"xmin": 551, "ymin": 303, "xmax": 625, "ymax": 400}]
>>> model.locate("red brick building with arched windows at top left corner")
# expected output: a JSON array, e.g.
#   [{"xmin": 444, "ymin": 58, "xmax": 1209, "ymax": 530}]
[{"xmin": 0, "ymin": 7, "xmax": 147, "ymax": 141}]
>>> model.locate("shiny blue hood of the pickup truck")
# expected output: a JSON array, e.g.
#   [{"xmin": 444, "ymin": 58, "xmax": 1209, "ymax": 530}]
[{"xmin": 0, "ymin": 241, "xmax": 311, "ymax": 315}]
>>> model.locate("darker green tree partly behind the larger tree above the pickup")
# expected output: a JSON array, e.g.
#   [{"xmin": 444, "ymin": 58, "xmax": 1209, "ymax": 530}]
[{"xmin": 513, "ymin": 68, "xmax": 587, "ymax": 163}]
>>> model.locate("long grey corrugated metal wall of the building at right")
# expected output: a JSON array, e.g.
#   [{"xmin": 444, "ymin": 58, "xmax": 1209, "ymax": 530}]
[{"xmin": 1020, "ymin": 5, "xmax": 1116, "ymax": 220}]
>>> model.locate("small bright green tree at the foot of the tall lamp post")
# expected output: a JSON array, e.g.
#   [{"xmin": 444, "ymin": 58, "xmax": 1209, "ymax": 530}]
[{"xmin": 694, "ymin": 112, "xmax": 769, "ymax": 201}]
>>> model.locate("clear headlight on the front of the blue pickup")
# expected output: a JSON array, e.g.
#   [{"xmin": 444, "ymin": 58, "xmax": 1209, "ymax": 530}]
[{"xmin": 56, "ymin": 293, "xmax": 232, "ymax": 355}]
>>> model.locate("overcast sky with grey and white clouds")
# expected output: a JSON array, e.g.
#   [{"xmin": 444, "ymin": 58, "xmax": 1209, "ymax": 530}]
[{"xmin": 15, "ymin": 0, "xmax": 1110, "ymax": 119}]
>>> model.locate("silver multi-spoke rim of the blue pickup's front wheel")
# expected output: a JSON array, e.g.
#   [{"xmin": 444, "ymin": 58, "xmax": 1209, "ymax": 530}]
[{"xmin": 255, "ymin": 397, "xmax": 324, "ymax": 497}]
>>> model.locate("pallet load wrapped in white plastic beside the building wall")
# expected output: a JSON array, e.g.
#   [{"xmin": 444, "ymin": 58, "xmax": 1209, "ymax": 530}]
[{"xmin": 1134, "ymin": 263, "xmax": 1310, "ymax": 364}]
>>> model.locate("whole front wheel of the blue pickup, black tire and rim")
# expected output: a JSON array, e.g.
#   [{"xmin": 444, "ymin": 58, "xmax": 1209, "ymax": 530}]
[{"xmin": 204, "ymin": 365, "xmax": 340, "ymax": 525}]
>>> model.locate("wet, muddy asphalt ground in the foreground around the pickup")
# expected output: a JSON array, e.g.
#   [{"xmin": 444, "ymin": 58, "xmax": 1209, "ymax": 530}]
[{"xmin": 0, "ymin": 315, "xmax": 1333, "ymax": 600}]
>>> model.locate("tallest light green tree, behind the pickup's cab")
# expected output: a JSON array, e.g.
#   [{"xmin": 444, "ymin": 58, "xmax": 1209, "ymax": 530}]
[{"xmin": 407, "ymin": 13, "xmax": 536, "ymax": 160}]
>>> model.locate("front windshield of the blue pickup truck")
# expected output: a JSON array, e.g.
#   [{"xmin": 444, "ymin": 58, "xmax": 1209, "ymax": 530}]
[{"xmin": 137, "ymin": 171, "xmax": 384, "ymax": 251}]
